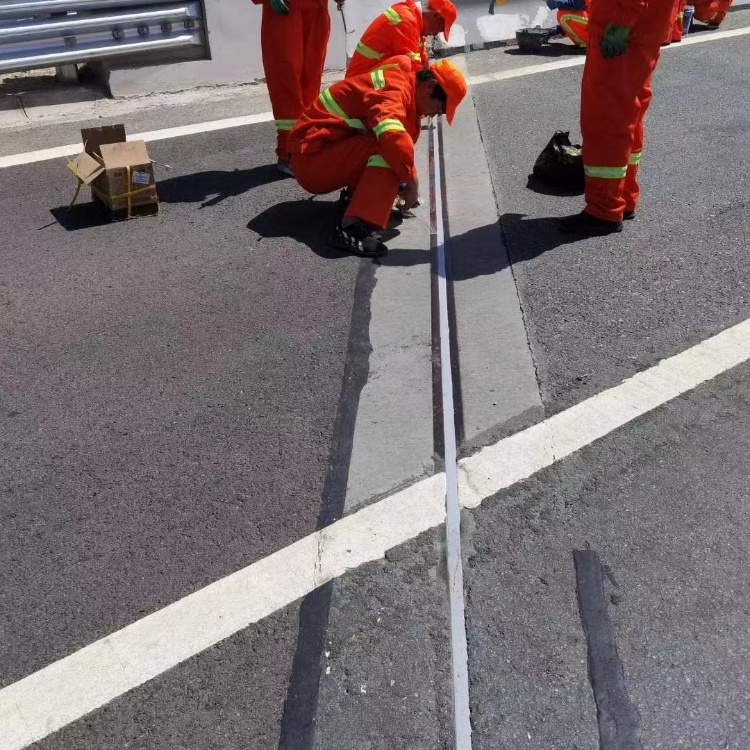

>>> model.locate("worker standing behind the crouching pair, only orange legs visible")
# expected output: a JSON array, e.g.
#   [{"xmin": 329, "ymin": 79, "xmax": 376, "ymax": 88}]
[{"xmin": 253, "ymin": 0, "xmax": 344, "ymax": 177}]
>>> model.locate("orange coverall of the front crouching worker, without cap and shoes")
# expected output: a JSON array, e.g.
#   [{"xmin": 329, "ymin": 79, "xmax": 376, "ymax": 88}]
[{"xmin": 289, "ymin": 56, "xmax": 421, "ymax": 229}]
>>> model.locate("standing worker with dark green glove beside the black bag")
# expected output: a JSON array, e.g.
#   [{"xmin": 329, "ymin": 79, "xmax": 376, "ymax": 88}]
[{"xmin": 560, "ymin": 0, "xmax": 674, "ymax": 236}]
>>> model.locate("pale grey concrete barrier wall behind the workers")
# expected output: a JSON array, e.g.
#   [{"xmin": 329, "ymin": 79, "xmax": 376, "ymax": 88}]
[{"xmin": 109, "ymin": 0, "xmax": 554, "ymax": 96}]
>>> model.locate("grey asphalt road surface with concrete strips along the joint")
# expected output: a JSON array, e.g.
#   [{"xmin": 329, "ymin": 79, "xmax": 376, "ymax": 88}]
[{"xmin": 0, "ymin": 11, "xmax": 750, "ymax": 750}]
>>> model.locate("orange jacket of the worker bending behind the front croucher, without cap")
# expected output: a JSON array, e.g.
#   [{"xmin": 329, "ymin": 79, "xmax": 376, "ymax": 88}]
[{"xmin": 346, "ymin": 0, "xmax": 429, "ymax": 78}]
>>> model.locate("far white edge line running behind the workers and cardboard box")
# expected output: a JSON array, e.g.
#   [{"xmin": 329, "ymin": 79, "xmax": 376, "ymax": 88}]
[{"xmin": 0, "ymin": 22, "xmax": 750, "ymax": 169}]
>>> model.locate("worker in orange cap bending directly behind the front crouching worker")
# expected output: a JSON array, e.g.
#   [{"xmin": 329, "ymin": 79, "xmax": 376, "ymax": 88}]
[{"xmin": 346, "ymin": 0, "xmax": 458, "ymax": 78}]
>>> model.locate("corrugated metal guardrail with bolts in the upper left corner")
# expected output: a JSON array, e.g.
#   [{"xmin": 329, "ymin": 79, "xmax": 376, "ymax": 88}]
[{"xmin": 0, "ymin": 0, "xmax": 206, "ymax": 73}]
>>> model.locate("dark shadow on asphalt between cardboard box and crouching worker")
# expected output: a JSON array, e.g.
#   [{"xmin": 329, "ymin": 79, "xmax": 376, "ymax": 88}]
[{"xmin": 158, "ymin": 164, "xmax": 289, "ymax": 208}]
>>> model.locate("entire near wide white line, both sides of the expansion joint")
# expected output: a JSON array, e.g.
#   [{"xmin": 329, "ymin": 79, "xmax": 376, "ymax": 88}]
[{"xmin": 0, "ymin": 319, "xmax": 750, "ymax": 750}]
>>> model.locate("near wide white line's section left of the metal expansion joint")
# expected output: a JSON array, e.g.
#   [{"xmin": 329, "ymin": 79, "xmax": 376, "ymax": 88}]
[{"xmin": 0, "ymin": 474, "xmax": 445, "ymax": 750}]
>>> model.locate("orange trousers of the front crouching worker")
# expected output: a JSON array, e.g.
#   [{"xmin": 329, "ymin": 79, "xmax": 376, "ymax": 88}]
[{"xmin": 292, "ymin": 133, "xmax": 399, "ymax": 229}]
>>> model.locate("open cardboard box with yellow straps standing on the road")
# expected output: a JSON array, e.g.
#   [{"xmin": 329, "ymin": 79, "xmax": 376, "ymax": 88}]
[{"xmin": 68, "ymin": 125, "xmax": 159, "ymax": 219}]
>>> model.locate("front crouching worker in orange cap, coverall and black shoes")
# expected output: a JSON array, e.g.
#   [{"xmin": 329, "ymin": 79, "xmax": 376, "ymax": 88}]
[{"xmin": 289, "ymin": 55, "xmax": 466, "ymax": 258}]
